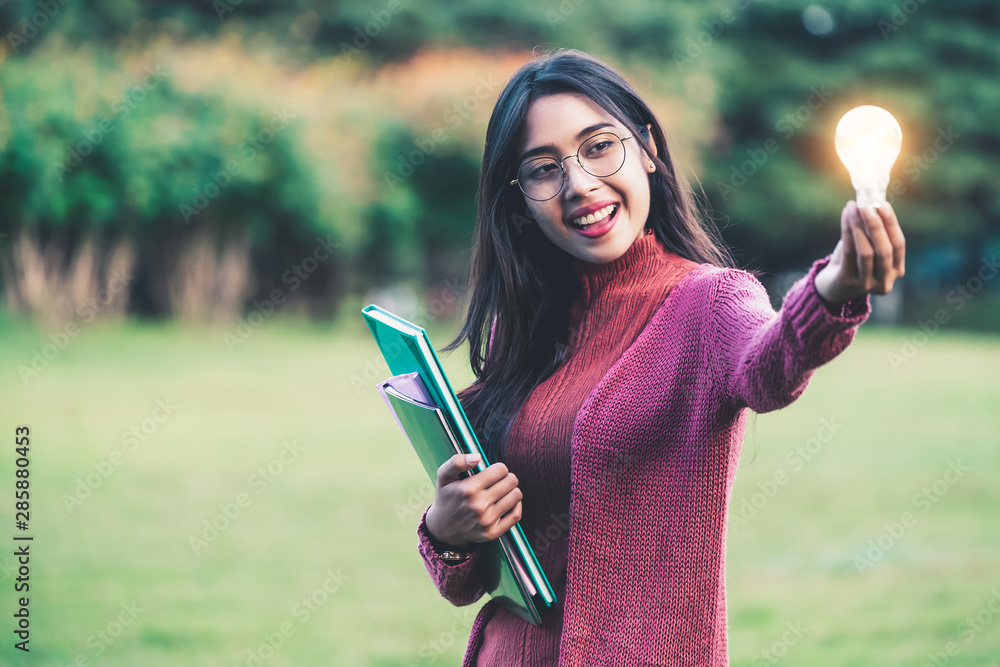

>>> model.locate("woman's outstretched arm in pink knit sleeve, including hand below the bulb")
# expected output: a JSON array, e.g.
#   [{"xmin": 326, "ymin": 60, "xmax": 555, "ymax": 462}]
[{"xmin": 706, "ymin": 201, "xmax": 906, "ymax": 412}]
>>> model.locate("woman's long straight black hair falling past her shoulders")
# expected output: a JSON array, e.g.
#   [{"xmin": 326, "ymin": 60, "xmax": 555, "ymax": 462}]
[{"xmin": 441, "ymin": 50, "xmax": 734, "ymax": 463}]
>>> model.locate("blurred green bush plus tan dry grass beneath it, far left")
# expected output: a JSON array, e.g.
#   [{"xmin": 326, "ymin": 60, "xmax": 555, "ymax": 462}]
[{"xmin": 0, "ymin": 43, "xmax": 328, "ymax": 321}]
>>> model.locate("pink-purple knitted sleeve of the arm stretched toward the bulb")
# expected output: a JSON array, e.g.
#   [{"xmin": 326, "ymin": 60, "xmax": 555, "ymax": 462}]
[{"xmin": 706, "ymin": 255, "xmax": 871, "ymax": 413}]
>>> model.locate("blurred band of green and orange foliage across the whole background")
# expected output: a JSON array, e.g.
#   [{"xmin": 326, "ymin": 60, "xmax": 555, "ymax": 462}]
[{"xmin": 0, "ymin": 0, "xmax": 1000, "ymax": 320}]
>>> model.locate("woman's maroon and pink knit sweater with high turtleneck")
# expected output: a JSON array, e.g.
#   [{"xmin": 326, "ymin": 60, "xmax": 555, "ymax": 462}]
[{"xmin": 417, "ymin": 234, "xmax": 870, "ymax": 666}]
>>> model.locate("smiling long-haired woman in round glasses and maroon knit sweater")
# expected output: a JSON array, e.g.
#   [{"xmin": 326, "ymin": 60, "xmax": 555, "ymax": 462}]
[{"xmin": 417, "ymin": 51, "xmax": 904, "ymax": 665}]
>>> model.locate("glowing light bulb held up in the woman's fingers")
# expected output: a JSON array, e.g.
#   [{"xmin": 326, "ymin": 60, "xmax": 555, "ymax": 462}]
[{"xmin": 835, "ymin": 105, "xmax": 903, "ymax": 207}]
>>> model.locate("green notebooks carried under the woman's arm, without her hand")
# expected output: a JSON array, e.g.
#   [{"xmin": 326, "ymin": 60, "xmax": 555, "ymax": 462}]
[{"xmin": 362, "ymin": 304, "xmax": 556, "ymax": 625}]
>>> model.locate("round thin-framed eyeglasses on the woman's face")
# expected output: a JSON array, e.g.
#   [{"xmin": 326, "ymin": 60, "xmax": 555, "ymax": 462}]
[{"xmin": 510, "ymin": 132, "xmax": 632, "ymax": 201}]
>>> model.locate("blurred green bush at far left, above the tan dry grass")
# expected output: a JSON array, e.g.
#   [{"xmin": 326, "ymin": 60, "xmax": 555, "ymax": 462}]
[{"xmin": 0, "ymin": 50, "xmax": 316, "ymax": 241}]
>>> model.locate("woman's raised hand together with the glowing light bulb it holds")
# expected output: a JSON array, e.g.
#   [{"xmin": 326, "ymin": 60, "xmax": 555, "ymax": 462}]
[{"xmin": 815, "ymin": 106, "xmax": 906, "ymax": 304}]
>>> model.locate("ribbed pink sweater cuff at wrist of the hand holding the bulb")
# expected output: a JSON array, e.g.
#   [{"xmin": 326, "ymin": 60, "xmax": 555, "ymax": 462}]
[{"xmin": 781, "ymin": 255, "xmax": 872, "ymax": 340}]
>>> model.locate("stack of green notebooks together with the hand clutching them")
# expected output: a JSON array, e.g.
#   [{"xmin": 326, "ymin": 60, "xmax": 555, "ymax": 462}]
[{"xmin": 362, "ymin": 304, "xmax": 556, "ymax": 625}]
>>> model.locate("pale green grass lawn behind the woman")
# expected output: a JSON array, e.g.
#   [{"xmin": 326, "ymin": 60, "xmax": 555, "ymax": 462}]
[{"xmin": 0, "ymin": 306, "xmax": 1000, "ymax": 667}]
